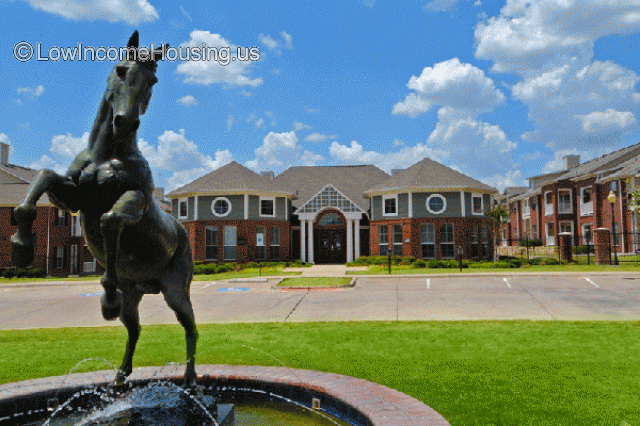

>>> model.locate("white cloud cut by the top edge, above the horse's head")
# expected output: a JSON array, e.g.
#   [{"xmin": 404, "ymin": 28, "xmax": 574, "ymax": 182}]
[{"xmin": 26, "ymin": 0, "xmax": 159, "ymax": 25}]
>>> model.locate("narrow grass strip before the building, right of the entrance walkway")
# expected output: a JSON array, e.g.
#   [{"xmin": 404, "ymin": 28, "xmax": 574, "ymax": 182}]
[{"xmin": 347, "ymin": 263, "xmax": 640, "ymax": 275}]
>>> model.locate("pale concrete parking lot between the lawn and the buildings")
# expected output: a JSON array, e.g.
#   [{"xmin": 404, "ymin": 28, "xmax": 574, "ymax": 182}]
[{"xmin": 0, "ymin": 274, "xmax": 640, "ymax": 329}]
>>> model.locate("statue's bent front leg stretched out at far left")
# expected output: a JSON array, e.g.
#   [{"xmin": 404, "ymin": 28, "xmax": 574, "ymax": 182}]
[{"xmin": 11, "ymin": 169, "xmax": 77, "ymax": 268}]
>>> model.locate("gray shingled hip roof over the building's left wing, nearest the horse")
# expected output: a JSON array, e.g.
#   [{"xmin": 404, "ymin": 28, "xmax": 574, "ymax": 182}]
[{"xmin": 166, "ymin": 161, "xmax": 294, "ymax": 198}]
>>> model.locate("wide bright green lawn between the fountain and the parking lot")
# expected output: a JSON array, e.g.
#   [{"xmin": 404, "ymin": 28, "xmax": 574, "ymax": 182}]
[{"xmin": 0, "ymin": 321, "xmax": 640, "ymax": 426}]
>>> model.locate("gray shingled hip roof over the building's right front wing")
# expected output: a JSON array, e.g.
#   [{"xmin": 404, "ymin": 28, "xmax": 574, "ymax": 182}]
[{"xmin": 364, "ymin": 158, "xmax": 498, "ymax": 196}]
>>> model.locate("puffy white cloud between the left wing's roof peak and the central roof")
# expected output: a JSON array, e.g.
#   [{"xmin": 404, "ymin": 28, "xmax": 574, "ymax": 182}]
[{"xmin": 245, "ymin": 131, "xmax": 324, "ymax": 172}]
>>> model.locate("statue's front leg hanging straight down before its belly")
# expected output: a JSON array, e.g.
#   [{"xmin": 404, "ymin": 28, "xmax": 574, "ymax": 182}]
[{"xmin": 100, "ymin": 191, "xmax": 147, "ymax": 321}]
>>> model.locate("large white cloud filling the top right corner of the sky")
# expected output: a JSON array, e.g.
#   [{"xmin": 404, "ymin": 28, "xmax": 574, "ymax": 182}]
[{"xmin": 475, "ymin": 0, "xmax": 640, "ymax": 74}]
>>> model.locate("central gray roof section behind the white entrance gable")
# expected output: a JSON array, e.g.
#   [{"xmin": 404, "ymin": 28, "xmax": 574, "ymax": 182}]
[{"xmin": 273, "ymin": 165, "xmax": 389, "ymax": 212}]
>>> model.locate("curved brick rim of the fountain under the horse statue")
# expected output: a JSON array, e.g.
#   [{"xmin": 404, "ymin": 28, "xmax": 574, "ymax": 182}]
[{"xmin": 0, "ymin": 365, "xmax": 449, "ymax": 426}]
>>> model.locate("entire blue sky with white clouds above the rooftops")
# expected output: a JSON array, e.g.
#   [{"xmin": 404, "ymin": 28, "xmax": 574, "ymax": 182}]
[{"xmin": 0, "ymin": 0, "xmax": 640, "ymax": 190}]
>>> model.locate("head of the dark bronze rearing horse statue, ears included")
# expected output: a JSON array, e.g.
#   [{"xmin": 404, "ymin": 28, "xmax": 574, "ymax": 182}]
[{"xmin": 105, "ymin": 31, "xmax": 161, "ymax": 139}]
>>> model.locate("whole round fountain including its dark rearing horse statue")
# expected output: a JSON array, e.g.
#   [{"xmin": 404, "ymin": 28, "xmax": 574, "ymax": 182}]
[{"xmin": 0, "ymin": 31, "xmax": 448, "ymax": 426}]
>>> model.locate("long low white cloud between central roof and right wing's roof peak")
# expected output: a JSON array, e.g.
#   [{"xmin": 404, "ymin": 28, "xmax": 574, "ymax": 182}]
[{"xmin": 329, "ymin": 141, "xmax": 448, "ymax": 173}]
